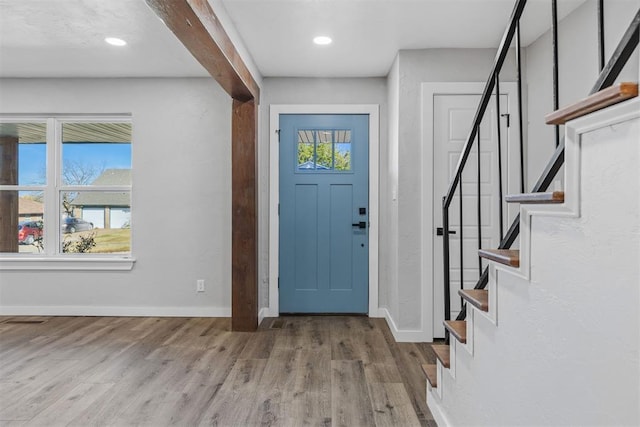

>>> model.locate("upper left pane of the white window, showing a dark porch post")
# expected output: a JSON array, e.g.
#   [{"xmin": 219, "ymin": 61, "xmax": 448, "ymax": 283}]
[{"xmin": 0, "ymin": 123, "xmax": 47, "ymax": 185}]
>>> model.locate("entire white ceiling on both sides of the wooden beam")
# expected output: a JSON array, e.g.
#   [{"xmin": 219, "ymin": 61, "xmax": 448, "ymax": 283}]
[{"xmin": 0, "ymin": 0, "xmax": 585, "ymax": 77}]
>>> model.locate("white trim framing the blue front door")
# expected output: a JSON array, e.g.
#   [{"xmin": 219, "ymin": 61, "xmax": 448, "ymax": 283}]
[{"xmin": 268, "ymin": 104, "xmax": 381, "ymax": 317}]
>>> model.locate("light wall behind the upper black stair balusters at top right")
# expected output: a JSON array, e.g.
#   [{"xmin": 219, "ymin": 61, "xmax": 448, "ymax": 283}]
[{"xmin": 525, "ymin": 0, "xmax": 640, "ymax": 189}]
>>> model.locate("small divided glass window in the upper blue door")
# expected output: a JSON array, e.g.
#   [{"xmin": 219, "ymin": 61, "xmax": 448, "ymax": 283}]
[{"xmin": 297, "ymin": 129, "xmax": 352, "ymax": 171}]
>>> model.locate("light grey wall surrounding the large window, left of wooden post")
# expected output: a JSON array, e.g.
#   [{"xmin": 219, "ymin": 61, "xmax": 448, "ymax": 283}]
[{"xmin": 0, "ymin": 78, "xmax": 231, "ymax": 316}]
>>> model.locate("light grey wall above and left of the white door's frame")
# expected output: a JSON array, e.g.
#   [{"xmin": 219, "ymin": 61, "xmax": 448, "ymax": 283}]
[{"xmin": 387, "ymin": 49, "xmax": 515, "ymax": 331}]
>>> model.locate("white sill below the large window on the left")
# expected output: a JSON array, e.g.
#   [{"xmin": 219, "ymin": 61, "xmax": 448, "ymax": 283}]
[{"xmin": 0, "ymin": 256, "xmax": 136, "ymax": 271}]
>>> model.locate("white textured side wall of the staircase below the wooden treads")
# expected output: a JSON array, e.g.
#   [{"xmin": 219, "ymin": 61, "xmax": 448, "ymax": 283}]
[{"xmin": 427, "ymin": 99, "xmax": 640, "ymax": 425}]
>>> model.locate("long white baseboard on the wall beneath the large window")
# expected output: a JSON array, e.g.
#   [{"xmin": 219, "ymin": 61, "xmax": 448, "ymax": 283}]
[{"xmin": 0, "ymin": 305, "xmax": 231, "ymax": 317}]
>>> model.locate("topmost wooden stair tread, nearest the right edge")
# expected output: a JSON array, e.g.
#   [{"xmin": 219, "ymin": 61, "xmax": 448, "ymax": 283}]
[{"xmin": 545, "ymin": 82, "xmax": 638, "ymax": 125}]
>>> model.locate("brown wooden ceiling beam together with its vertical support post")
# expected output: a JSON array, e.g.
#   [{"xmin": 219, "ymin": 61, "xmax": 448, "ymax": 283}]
[{"xmin": 146, "ymin": 0, "xmax": 260, "ymax": 332}]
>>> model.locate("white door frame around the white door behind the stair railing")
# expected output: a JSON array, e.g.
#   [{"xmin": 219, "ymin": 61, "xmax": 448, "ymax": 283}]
[{"xmin": 422, "ymin": 82, "xmax": 526, "ymax": 342}]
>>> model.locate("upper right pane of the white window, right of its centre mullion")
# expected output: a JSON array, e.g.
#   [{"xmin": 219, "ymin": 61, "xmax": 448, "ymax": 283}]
[{"xmin": 62, "ymin": 122, "xmax": 131, "ymax": 185}]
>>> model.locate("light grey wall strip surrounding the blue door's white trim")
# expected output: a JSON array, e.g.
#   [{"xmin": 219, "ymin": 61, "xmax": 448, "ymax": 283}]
[{"xmin": 258, "ymin": 77, "xmax": 387, "ymax": 309}]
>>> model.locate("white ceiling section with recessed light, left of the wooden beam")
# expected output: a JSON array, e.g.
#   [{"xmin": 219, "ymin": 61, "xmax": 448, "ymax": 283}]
[{"xmin": 0, "ymin": 0, "xmax": 208, "ymax": 77}]
